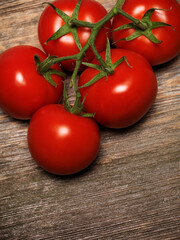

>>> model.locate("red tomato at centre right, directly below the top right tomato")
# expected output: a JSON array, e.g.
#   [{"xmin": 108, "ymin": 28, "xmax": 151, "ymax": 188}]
[{"xmin": 79, "ymin": 49, "xmax": 157, "ymax": 128}]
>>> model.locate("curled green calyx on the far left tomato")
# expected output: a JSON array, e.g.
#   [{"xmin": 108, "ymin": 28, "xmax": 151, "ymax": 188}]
[{"xmin": 34, "ymin": 55, "xmax": 66, "ymax": 87}]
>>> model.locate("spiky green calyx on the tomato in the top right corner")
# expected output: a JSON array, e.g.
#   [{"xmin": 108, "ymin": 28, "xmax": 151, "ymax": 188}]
[{"xmin": 113, "ymin": 8, "xmax": 172, "ymax": 44}]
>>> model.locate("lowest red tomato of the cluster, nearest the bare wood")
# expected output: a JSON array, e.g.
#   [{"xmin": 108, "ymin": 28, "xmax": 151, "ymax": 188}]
[{"xmin": 28, "ymin": 104, "xmax": 100, "ymax": 175}]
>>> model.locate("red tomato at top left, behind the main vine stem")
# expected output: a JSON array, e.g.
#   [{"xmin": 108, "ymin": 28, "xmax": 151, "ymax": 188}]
[{"xmin": 38, "ymin": 0, "xmax": 111, "ymax": 71}]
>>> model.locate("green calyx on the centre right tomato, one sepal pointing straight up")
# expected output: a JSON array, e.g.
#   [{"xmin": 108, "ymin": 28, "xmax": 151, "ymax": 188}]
[{"xmin": 79, "ymin": 38, "xmax": 131, "ymax": 88}]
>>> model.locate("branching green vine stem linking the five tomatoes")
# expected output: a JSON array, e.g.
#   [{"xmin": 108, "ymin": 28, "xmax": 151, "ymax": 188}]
[{"xmin": 38, "ymin": 0, "xmax": 147, "ymax": 114}]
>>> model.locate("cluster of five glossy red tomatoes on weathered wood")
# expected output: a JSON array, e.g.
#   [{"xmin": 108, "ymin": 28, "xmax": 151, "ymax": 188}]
[{"xmin": 0, "ymin": 0, "xmax": 180, "ymax": 175}]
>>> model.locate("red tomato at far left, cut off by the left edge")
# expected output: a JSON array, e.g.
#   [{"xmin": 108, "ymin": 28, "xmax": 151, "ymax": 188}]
[{"xmin": 0, "ymin": 45, "xmax": 63, "ymax": 119}]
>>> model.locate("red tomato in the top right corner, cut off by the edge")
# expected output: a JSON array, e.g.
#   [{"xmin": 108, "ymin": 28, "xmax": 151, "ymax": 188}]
[{"xmin": 112, "ymin": 0, "xmax": 180, "ymax": 65}]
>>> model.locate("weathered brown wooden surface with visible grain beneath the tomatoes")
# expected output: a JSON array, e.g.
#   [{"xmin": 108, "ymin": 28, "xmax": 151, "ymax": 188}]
[{"xmin": 0, "ymin": 0, "xmax": 180, "ymax": 240}]
